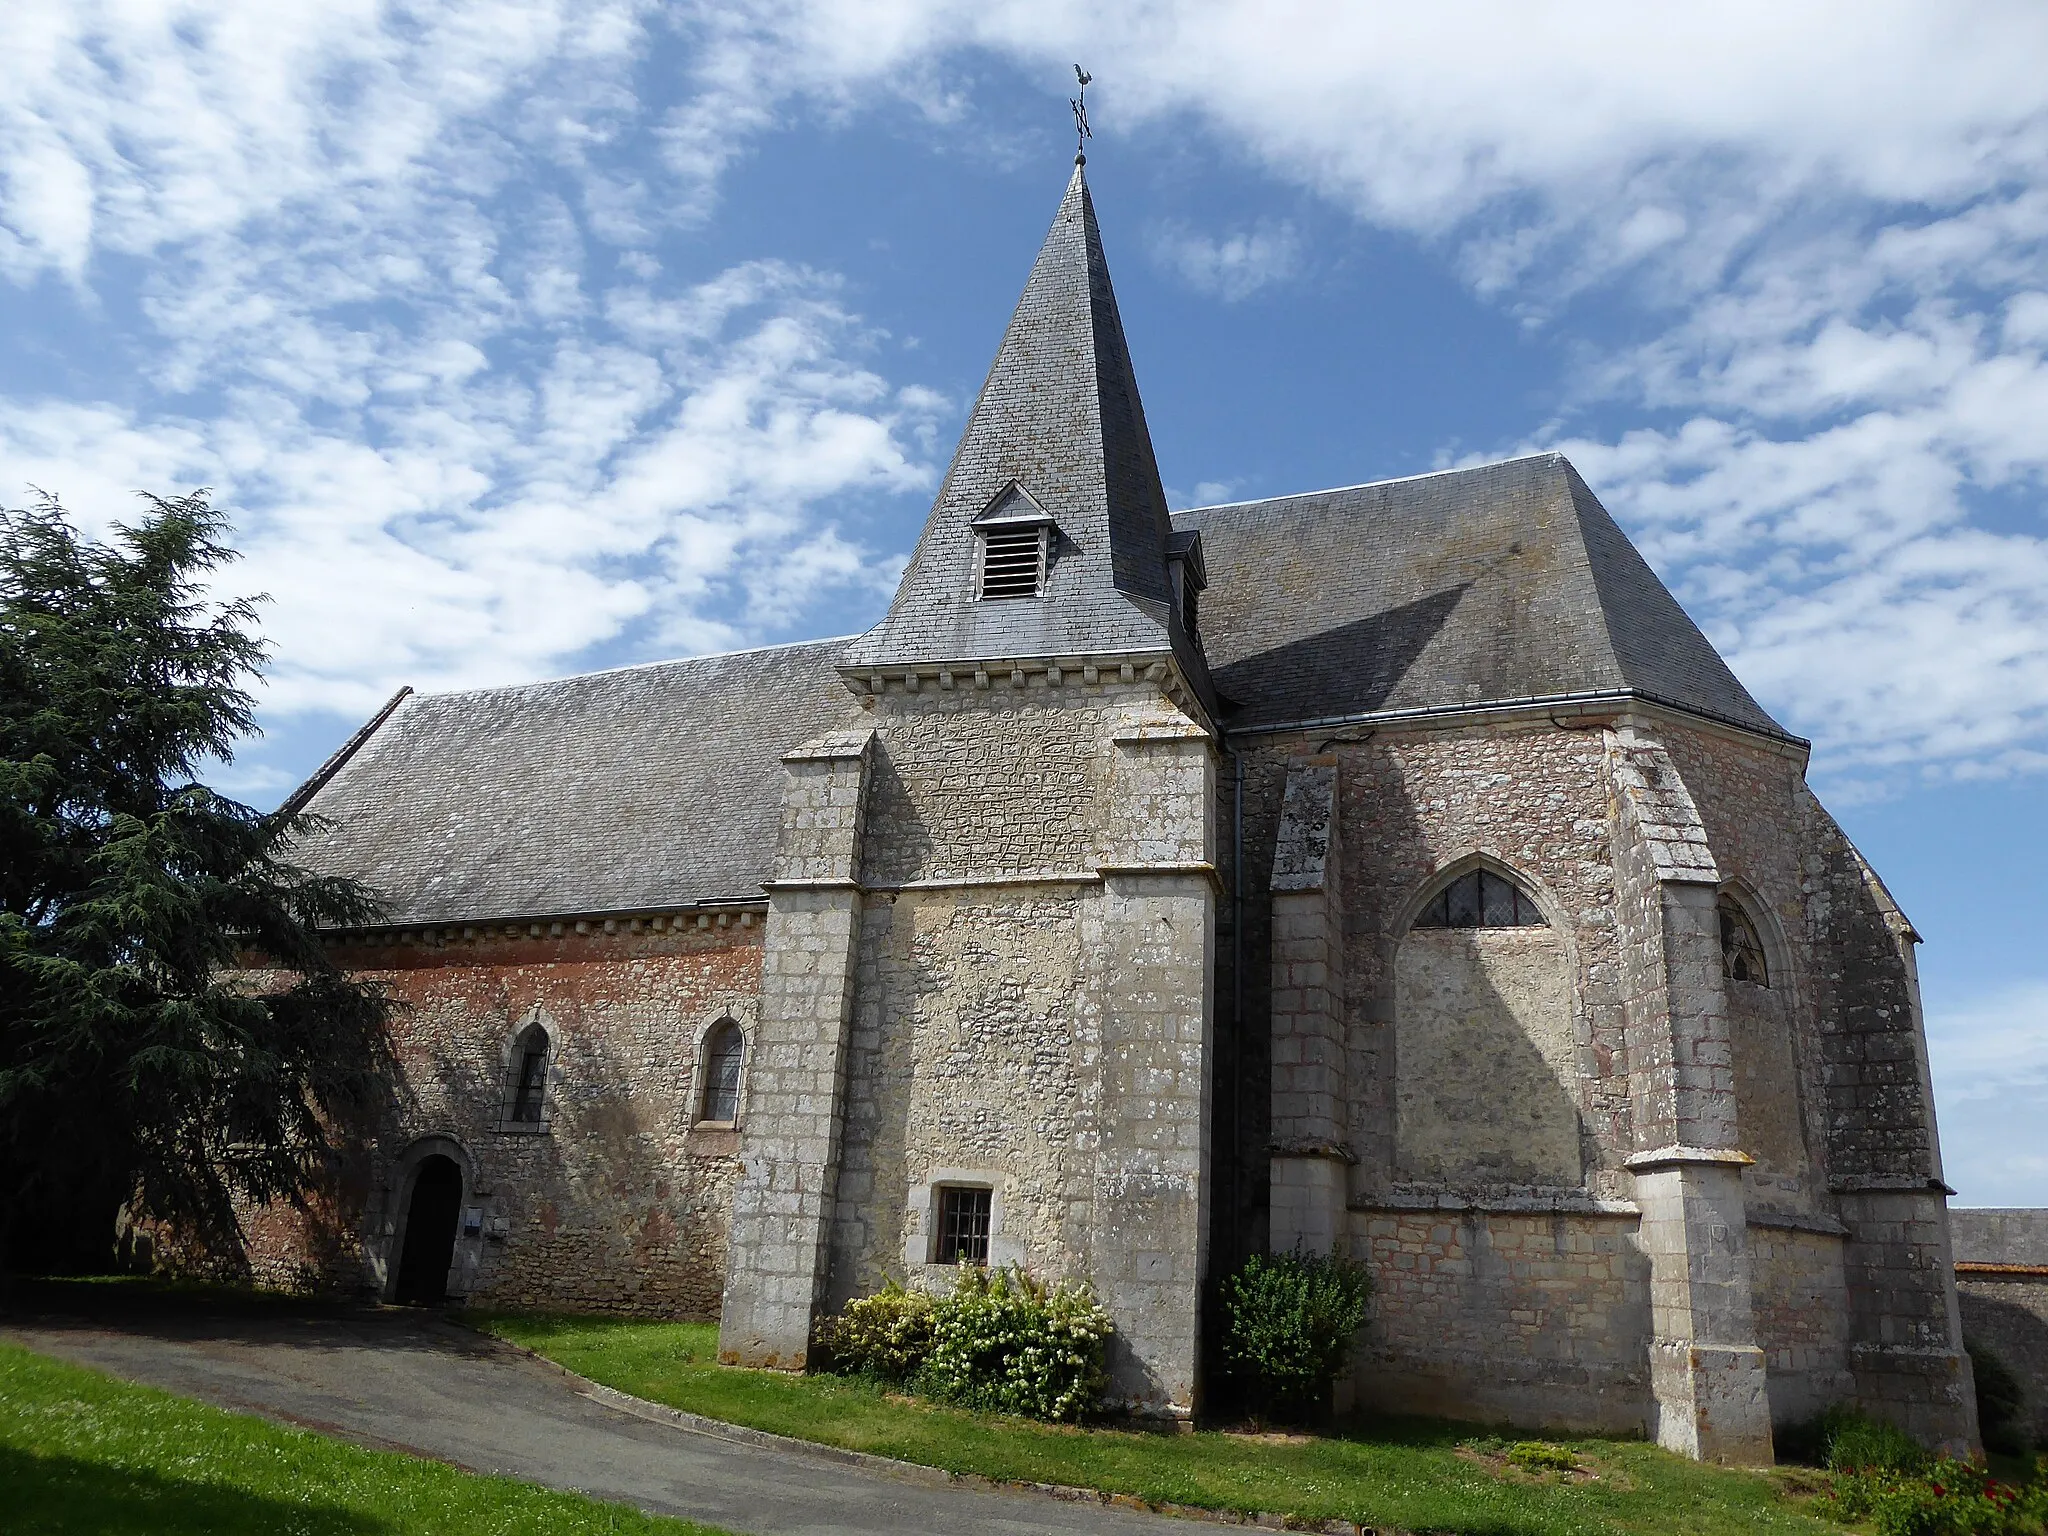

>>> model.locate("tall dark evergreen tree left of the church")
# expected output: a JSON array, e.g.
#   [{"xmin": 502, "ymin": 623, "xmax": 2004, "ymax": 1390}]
[{"xmin": 0, "ymin": 494, "xmax": 389, "ymax": 1270}]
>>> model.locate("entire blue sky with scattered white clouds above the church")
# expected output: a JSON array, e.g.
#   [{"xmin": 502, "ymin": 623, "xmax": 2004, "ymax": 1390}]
[{"xmin": 0, "ymin": 0, "xmax": 2048, "ymax": 1204}]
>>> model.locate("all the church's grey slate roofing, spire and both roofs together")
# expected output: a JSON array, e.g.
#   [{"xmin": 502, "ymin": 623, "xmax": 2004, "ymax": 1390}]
[{"xmin": 295, "ymin": 185, "xmax": 1786, "ymax": 926}]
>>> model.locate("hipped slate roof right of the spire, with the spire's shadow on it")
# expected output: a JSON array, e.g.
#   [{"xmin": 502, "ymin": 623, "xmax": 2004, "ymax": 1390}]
[{"xmin": 1174, "ymin": 453, "xmax": 1786, "ymax": 737}]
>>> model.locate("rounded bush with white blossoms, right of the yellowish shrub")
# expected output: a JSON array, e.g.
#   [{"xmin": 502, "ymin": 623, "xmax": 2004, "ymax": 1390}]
[{"xmin": 918, "ymin": 1264, "xmax": 1114, "ymax": 1419}]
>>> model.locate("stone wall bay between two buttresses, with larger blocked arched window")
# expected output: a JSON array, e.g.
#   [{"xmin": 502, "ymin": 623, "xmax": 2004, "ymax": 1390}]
[{"xmin": 1343, "ymin": 735, "xmax": 1651, "ymax": 1432}]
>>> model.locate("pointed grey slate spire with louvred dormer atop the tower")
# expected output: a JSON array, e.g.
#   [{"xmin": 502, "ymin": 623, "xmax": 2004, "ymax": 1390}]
[{"xmin": 844, "ymin": 164, "xmax": 1208, "ymax": 694}]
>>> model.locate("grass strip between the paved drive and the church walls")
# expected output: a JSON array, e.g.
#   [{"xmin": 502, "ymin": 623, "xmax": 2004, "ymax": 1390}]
[{"xmin": 471, "ymin": 1315, "xmax": 1843, "ymax": 1536}]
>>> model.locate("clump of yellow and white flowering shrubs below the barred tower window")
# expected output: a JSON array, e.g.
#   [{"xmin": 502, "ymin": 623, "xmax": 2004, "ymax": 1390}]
[{"xmin": 823, "ymin": 1264, "xmax": 1114, "ymax": 1419}]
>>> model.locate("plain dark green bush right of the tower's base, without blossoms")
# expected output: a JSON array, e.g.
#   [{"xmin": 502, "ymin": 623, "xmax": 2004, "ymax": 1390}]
[{"xmin": 1223, "ymin": 1251, "xmax": 1372, "ymax": 1419}]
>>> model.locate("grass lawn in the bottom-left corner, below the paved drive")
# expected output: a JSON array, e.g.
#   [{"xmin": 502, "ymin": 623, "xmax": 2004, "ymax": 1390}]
[{"xmin": 0, "ymin": 1343, "xmax": 719, "ymax": 1536}]
